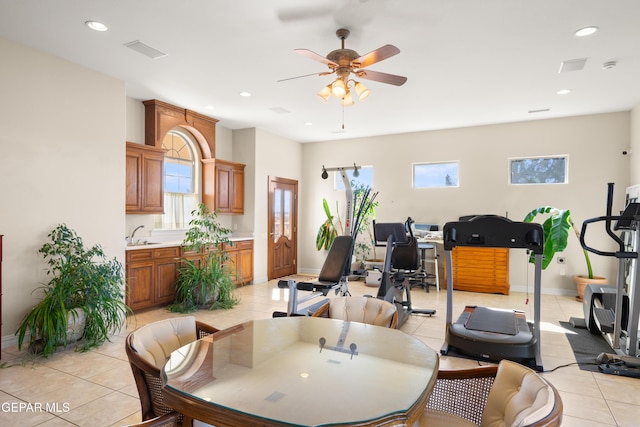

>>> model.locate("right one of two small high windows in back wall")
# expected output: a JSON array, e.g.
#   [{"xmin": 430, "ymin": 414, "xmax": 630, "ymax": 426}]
[{"xmin": 509, "ymin": 156, "xmax": 568, "ymax": 185}]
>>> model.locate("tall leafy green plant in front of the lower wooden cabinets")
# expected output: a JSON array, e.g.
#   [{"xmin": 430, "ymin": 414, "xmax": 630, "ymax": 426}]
[{"xmin": 169, "ymin": 203, "xmax": 239, "ymax": 313}]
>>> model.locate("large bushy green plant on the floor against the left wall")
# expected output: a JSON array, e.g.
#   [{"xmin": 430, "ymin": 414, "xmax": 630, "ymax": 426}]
[{"xmin": 16, "ymin": 224, "xmax": 129, "ymax": 357}]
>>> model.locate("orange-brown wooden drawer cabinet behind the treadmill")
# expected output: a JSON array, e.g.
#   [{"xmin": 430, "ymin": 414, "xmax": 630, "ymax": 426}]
[{"xmin": 439, "ymin": 246, "xmax": 509, "ymax": 295}]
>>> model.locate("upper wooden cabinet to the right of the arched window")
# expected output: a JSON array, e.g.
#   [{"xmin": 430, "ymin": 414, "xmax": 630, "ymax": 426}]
[{"xmin": 202, "ymin": 159, "xmax": 245, "ymax": 215}]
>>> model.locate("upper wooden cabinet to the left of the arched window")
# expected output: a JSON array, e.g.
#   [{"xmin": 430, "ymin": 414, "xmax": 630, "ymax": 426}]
[{"xmin": 125, "ymin": 142, "xmax": 164, "ymax": 214}]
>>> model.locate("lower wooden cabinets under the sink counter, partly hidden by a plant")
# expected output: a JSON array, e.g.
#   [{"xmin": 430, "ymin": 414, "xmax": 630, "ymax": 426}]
[{"xmin": 126, "ymin": 240, "xmax": 253, "ymax": 311}]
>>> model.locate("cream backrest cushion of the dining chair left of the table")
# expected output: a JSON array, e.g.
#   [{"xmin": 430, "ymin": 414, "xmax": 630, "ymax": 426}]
[{"xmin": 132, "ymin": 316, "xmax": 197, "ymax": 369}]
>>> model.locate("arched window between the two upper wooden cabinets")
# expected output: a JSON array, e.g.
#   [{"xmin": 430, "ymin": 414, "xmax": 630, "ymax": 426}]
[{"xmin": 156, "ymin": 129, "xmax": 200, "ymax": 229}]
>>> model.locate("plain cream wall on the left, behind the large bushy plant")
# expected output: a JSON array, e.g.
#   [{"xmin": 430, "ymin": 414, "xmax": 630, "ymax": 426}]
[{"xmin": 0, "ymin": 39, "xmax": 126, "ymax": 346}]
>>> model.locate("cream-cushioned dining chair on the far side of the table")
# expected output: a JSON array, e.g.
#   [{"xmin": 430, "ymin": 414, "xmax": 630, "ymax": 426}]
[{"xmin": 313, "ymin": 296, "xmax": 398, "ymax": 329}]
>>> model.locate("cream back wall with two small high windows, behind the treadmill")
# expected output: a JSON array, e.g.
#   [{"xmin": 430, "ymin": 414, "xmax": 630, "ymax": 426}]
[{"xmin": 299, "ymin": 112, "xmax": 630, "ymax": 294}]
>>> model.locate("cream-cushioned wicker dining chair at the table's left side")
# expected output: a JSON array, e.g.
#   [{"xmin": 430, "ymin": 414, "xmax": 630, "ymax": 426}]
[{"xmin": 125, "ymin": 316, "xmax": 218, "ymax": 425}]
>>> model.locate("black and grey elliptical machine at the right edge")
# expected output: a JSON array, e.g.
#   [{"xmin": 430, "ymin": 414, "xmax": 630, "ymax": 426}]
[{"xmin": 571, "ymin": 183, "xmax": 640, "ymax": 377}]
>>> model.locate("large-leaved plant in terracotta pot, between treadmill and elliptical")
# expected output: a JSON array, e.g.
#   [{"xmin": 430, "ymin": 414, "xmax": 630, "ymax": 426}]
[{"xmin": 524, "ymin": 206, "xmax": 607, "ymax": 301}]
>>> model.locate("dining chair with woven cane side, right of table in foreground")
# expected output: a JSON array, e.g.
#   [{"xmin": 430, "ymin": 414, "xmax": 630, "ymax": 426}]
[{"xmin": 414, "ymin": 360, "xmax": 563, "ymax": 427}]
